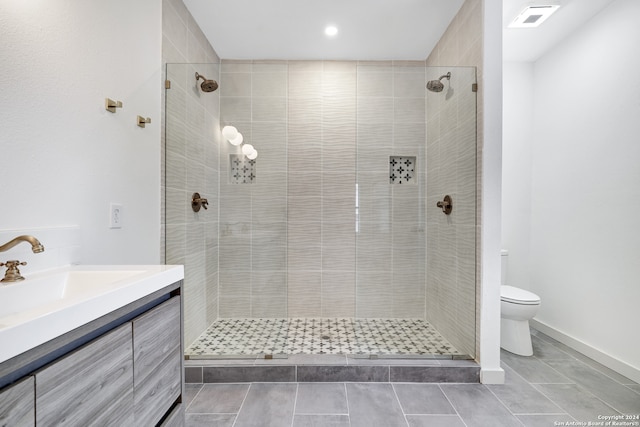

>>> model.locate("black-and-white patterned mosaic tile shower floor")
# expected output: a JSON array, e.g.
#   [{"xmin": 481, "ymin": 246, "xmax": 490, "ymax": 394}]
[{"xmin": 185, "ymin": 318, "xmax": 461, "ymax": 359}]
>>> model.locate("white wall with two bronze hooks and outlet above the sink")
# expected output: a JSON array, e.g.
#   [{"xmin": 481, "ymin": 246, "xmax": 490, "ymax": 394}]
[{"xmin": 0, "ymin": 0, "xmax": 162, "ymax": 264}]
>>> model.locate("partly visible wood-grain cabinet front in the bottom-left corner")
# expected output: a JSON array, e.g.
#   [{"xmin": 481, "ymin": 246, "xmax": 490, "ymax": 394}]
[{"xmin": 0, "ymin": 377, "xmax": 36, "ymax": 427}]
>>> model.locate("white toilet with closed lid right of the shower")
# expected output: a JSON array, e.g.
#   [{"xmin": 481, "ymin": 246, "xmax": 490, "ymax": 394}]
[{"xmin": 500, "ymin": 250, "xmax": 540, "ymax": 356}]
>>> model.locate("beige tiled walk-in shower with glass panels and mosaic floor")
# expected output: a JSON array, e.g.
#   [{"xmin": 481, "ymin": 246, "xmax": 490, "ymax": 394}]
[{"xmin": 165, "ymin": 60, "xmax": 476, "ymax": 358}]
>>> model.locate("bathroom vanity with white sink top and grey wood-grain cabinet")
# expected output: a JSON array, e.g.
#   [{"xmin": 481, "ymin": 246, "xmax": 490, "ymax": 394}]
[{"xmin": 0, "ymin": 266, "xmax": 184, "ymax": 426}]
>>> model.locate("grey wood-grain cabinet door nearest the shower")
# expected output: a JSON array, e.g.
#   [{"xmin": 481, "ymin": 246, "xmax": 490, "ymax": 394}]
[{"xmin": 133, "ymin": 296, "xmax": 183, "ymax": 426}]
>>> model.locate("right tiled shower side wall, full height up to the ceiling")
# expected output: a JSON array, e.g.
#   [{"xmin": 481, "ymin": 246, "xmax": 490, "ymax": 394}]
[{"xmin": 427, "ymin": 0, "xmax": 483, "ymax": 357}]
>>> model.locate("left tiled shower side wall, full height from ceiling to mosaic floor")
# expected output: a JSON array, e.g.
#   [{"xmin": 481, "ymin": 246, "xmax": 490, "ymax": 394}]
[{"xmin": 162, "ymin": 0, "xmax": 220, "ymax": 344}]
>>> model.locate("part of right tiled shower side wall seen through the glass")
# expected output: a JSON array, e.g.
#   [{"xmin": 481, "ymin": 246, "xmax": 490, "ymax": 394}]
[{"xmin": 427, "ymin": 67, "xmax": 476, "ymax": 355}]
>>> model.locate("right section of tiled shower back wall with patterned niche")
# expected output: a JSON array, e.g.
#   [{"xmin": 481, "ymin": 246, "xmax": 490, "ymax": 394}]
[{"xmin": 356, "ymin": 62, "xmax": 426, "ymax": 318}]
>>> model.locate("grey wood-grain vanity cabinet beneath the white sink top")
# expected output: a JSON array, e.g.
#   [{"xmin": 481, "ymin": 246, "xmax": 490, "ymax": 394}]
[{"xmin": 0, "ymin": 290, "xmax": 184, "ymax": 427}]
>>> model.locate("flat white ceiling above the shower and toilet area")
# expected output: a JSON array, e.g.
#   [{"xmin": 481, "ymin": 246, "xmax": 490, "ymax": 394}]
[{"xmin": 184, "ymin": 0, "xmax": 614, "ymax": 61}]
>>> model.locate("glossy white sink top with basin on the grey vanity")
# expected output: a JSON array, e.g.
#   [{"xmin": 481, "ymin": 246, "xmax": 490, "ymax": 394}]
[{"xmin": 0, "ymin": 265, "xmax": 184, "ymax": 363}]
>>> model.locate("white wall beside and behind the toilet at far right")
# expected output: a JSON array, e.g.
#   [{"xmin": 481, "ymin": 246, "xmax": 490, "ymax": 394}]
[{"xmin": 503, "ymin": 0, "xmax": 640, "ymax": 379}]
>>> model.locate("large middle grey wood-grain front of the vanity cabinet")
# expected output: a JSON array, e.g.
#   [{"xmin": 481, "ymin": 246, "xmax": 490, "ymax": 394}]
[{"xmin": 35, "ymin": 323, "xmax": 133, "ymax": 426}]
